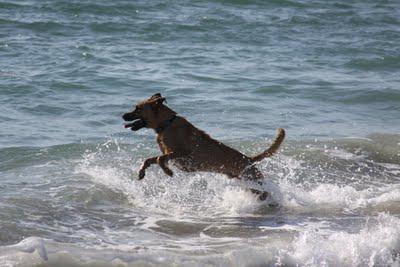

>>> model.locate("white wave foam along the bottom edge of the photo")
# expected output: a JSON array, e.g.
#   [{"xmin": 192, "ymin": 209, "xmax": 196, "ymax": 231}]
[{"xmin": 0, "ymin": 213, "xmax": 400, "ymax": 266}]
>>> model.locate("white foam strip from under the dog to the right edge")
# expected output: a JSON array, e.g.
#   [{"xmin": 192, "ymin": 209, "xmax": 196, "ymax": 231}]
[{"xmin": 76, "ymin": 143, "xmax": 400, "ymax": 216}]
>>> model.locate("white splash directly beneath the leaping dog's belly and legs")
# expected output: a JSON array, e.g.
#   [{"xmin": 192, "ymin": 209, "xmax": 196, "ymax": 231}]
[{"xmin": 76, "ymin": 148, "xmax": 282, "ymax": 219}]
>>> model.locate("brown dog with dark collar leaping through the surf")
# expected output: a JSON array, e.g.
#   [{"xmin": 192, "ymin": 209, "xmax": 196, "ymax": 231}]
[{"xmin": 122, "ymin": 93, "xmax": 285, "ymax": 200}]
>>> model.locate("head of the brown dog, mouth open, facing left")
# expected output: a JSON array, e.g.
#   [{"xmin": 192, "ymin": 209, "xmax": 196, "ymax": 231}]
[{"xmin": 122, "ymin": 93, "xmax": 175, "ymax": 131}]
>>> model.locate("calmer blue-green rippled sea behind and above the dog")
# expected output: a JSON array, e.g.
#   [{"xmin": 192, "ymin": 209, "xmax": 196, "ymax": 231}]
[{"xmin": 0, "ymin": 1, "xmax": 400, "ymax": 149}]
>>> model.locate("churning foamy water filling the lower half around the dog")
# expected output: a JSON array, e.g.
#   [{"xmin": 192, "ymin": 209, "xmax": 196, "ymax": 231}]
[{"xmin": 0, "ymin": 136, "xmax": 400, "ymax": 266}]
